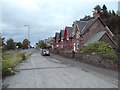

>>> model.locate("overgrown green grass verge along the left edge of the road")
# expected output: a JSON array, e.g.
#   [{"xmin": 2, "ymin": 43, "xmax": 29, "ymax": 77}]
[{"xmin": 2, "ymin": 53, "xmax": 31, "ymax": 77}]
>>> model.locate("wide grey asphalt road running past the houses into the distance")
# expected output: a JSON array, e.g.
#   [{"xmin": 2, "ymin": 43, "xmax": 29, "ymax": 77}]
[{"xmin": 3, "ymin": 49, "xmax": 118, "ymax": 88}]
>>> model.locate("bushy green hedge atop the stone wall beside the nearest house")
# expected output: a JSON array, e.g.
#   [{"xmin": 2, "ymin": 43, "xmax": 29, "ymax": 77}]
[{"xmin": 81, "ymin": 41, "xmax": 118, "ymax": 60}]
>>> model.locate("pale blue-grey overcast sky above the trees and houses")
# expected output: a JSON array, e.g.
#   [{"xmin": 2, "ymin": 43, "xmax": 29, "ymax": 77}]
[{"xmin": 0, "ymin": 0, "xmax": 119, "ymax": 45}]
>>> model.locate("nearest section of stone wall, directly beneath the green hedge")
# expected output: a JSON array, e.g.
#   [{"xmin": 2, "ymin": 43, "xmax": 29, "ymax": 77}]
[{"xmin": 75, "ymin": 53, "xmax": 118, "ymax": 70}]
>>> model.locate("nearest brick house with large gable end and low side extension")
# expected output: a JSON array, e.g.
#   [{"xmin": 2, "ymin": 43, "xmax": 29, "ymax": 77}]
[{"xmin": 72, "ymin": 17, "xmax": 116, "ymax": 51}]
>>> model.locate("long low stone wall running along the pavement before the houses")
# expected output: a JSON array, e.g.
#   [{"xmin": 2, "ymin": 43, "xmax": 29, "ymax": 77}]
[{"xmin": 51, "ymin": 50, "xmax": 118, "ymax": 70}]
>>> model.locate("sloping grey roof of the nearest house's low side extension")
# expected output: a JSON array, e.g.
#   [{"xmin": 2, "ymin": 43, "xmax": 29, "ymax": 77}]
[{"xmin": 84, "ymin": 31, "xmax": 106, "ymax": 46}]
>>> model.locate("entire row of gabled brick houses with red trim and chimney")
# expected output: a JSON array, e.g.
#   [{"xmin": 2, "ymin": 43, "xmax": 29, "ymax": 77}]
[{"xmin": 49, "ymin": 12, "xmax": 117, "ymax": 51}]
